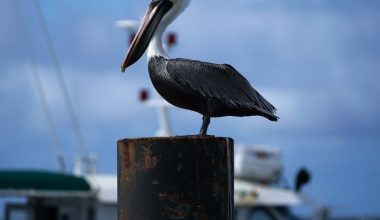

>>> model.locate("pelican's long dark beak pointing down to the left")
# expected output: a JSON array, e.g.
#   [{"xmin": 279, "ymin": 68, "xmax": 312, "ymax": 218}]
[{"xmin": 121, "ymin": 0, "xmax": 173, "ymax": 72}]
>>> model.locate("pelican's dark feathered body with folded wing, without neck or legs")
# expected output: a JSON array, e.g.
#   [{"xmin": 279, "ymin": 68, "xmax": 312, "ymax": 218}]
[{"xmin": 149, "ymin": 57, "xmax": 276, "ymax": 120}]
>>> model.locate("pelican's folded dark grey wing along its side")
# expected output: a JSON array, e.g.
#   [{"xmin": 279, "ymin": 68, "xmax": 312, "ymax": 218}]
[{"xmin": 166, "ymin": 59, "xmax": 277, "ymax": 119}]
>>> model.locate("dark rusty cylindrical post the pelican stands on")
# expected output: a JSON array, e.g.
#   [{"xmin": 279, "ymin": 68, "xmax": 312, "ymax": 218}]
[{"xmin": 118, "ymin": 136, "xmax": 234, "ymax": 220}]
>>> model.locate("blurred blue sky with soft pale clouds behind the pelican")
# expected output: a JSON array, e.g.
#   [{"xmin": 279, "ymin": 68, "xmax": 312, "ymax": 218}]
[{"xmin": 0, "ymin": 0, "xmax": 380, "ymax": 215}]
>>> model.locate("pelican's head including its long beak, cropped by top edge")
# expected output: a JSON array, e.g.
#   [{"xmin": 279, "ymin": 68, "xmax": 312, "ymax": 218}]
[{"xmin": 121, "ymin": 0, "xmax": 190, "ymax": 72}]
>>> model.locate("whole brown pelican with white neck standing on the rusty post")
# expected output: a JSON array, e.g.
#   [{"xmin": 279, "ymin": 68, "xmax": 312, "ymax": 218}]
[{"xmin": 121, "ymin": 0, "xmax": 278, "ymax": 135}]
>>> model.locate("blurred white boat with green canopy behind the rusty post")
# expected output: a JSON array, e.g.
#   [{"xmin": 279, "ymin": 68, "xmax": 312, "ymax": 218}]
[{"xmin": 0, "ymin": 146, "xmax": 306, "ymax": 220}]
